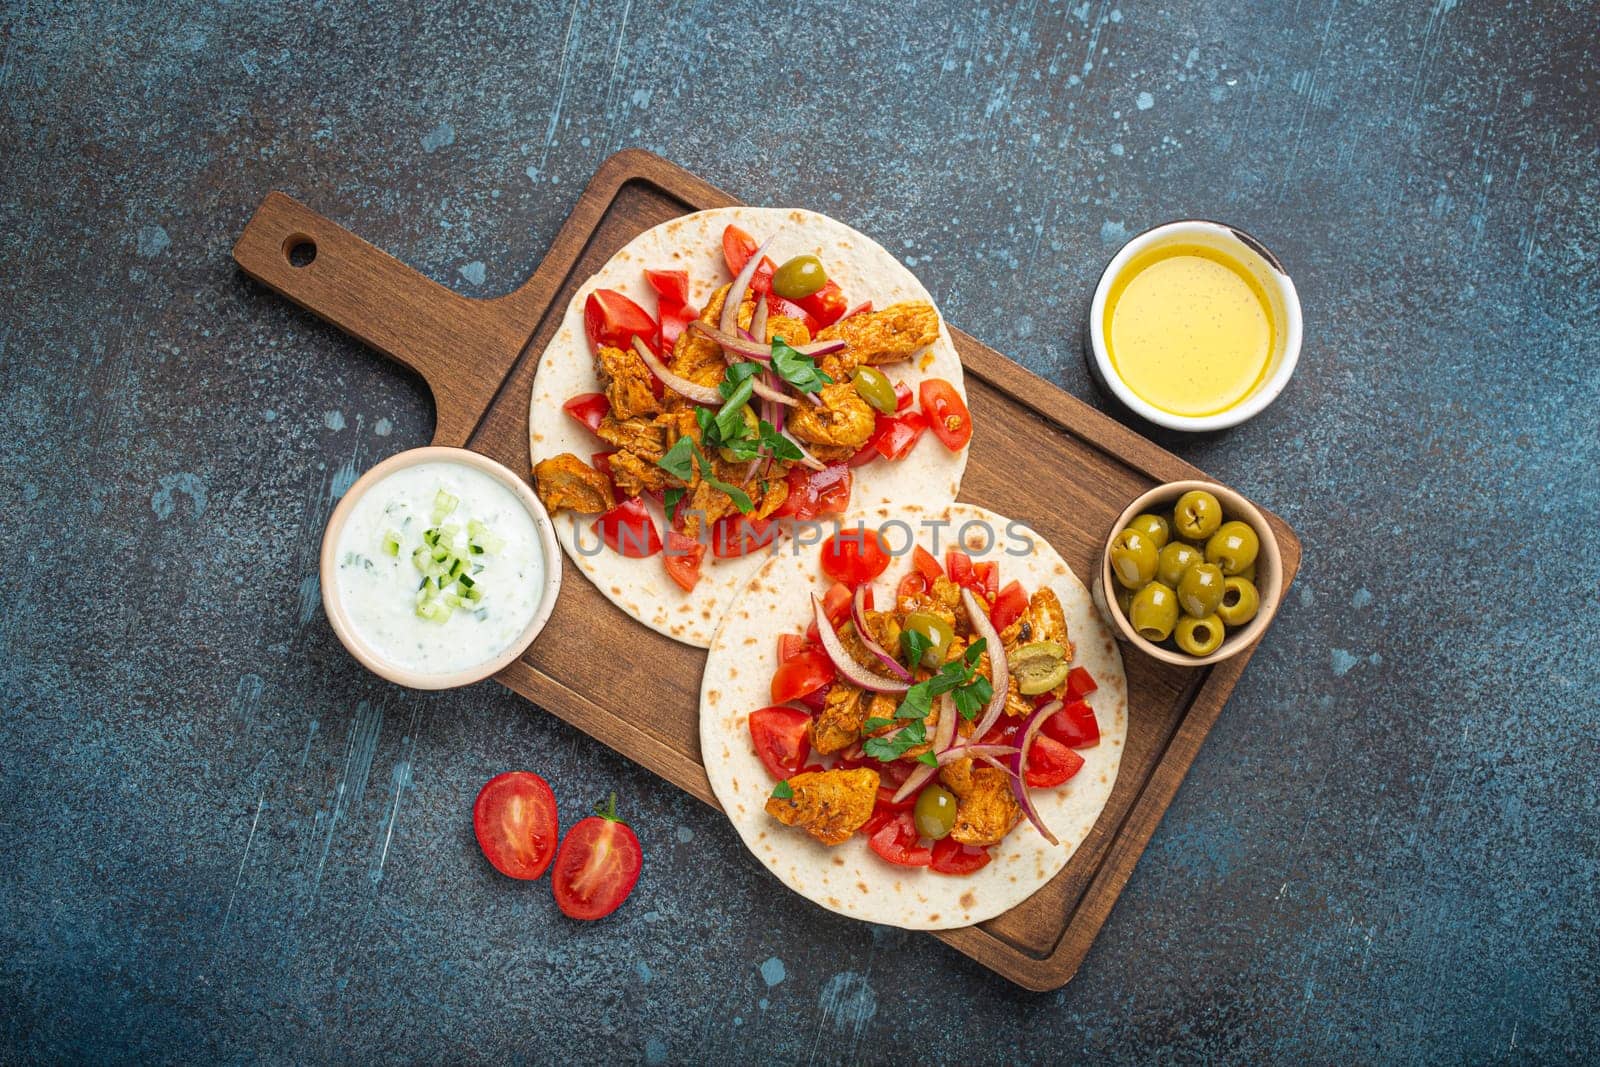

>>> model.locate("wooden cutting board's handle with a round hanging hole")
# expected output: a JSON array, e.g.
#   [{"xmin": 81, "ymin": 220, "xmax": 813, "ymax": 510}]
[{"xmin": 234, "ymin": 192, "xmax": 534, "ymax": 446}]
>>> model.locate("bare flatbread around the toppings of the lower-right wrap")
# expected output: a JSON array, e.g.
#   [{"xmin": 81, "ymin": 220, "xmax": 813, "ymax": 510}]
[{"xmin": 699, "ymin": 504, "xmax": 1128, "ymax": 929}]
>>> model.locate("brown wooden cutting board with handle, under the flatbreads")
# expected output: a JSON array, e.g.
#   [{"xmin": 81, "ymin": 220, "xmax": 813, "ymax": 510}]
[{"xmin": 234, "ymin": 150, "xmax": 1301, "ymax": 990}]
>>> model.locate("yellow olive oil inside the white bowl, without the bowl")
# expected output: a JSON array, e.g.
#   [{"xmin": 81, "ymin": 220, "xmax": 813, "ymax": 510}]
[{"xmin": 1102, "ymin": 243, "xmax": 1277, "ymax": 416}]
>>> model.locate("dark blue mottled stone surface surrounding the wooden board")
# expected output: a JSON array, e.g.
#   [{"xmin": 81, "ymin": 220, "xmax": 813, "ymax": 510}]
[{"xmin": 0, "ymin": 0, "xmax": 1600, "ymax": 1062}]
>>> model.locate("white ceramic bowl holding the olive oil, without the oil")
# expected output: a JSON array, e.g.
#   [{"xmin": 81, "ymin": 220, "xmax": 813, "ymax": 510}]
[{"xmin": 1083, "ymin": 219, "xmax": 1302, "ymax": 432}]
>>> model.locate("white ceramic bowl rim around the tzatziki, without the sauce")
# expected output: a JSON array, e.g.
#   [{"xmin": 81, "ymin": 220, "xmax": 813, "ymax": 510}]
[{"xmin": 322, "ymin": 445, "xmax": 562, "ymax": 689}]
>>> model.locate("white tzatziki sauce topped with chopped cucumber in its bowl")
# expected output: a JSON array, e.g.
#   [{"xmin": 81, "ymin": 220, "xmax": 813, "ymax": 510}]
[{"xmin": 338, "ymin": 461, "xmax": 547, "ymax": 673}]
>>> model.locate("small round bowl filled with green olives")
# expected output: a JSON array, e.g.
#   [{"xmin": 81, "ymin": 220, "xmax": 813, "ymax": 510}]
[{"xmin": 1096, "ymin": 482, "xmax": 1283, "ymax": 667}]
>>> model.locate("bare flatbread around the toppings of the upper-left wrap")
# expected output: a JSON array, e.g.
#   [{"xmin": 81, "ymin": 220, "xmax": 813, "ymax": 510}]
[{"xmin": 528, "ymin": 208, "xmax": 968, "ymax": 648}]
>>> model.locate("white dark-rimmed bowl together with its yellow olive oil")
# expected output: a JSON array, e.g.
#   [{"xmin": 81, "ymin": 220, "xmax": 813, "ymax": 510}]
[{"xmin": 1083, "ymin": 219, "xmax": 1302, "ymax": 432}]
